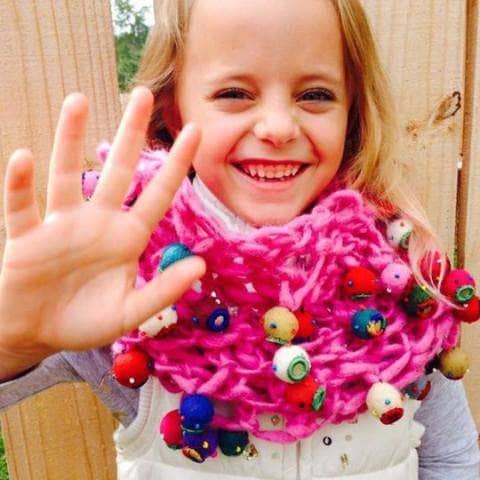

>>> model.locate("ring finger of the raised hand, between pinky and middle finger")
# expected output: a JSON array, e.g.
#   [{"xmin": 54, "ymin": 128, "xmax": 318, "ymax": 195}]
[{"xmin": 45, "ymin": 93, "xmax": 88, "ymax": 216}]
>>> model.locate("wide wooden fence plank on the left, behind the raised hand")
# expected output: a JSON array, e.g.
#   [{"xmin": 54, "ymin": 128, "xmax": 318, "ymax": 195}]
[{"xmin": 0, "ymin": 0, "xmax": 120, "ymax": 480}]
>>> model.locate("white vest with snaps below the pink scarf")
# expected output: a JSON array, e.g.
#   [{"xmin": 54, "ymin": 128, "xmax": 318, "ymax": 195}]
[{"xmin": 114, "ymin": 377, "xmax": 425, "ymax": 480}]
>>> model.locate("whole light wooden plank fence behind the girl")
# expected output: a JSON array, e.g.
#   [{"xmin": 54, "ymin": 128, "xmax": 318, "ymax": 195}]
[{"xmin": 0, "ymin": 0, "xmax": 480, "ymax": 480}]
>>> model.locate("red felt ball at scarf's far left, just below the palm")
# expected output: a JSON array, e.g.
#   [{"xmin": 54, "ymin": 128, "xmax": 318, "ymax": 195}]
[{"xmin": 112, "ymin": 349, "xmax": 152, "ymax": 388}]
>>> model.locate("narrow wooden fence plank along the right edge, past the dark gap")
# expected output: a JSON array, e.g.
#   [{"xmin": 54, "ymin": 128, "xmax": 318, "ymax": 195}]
[{"xmin": 458, "ymin": 0, "xmax": 480, "ymax": 430}]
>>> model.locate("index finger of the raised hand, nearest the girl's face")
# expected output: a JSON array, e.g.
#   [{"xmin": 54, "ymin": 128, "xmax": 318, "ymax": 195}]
[{"xmin": 131, "ymin": 124, "xmax": 201, "ymax": 231}]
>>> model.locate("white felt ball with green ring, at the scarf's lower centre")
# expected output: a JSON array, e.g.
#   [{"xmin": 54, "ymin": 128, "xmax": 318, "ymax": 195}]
[{"xmin": 272, "ymin": 345, "xmax": 311, "ymax": 383}]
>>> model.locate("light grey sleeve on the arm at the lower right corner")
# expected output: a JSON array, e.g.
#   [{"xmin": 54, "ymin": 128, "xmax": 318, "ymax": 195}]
[{"xmin": 415, "ymin": 372, "xmax": 480, "ymax": 480}]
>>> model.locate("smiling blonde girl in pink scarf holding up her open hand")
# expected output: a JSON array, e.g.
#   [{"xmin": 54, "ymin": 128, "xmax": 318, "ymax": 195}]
[{"xmin": 0, "ymin": 0, "xmax": 480, "ymax": 480}]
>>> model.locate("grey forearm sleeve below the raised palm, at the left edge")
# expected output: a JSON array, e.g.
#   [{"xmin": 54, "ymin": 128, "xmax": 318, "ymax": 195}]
[{"xmin": 0, "ymin": 353, "xmax": 82, "ymax": 410}]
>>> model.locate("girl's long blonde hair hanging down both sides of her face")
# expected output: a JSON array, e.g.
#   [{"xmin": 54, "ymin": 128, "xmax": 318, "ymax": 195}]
[{"xmin": 131, "ymin": 0, "xmax": 454, "ymax": 306}]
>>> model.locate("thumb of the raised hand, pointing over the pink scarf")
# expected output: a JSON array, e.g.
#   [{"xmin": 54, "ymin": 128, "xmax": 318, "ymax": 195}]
[{"xmin": 123, "ymin": 256, "xmax": 206, "ymax": 333}]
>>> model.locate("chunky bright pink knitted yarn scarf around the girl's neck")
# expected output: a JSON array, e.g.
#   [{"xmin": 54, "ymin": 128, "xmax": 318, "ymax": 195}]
[{"xmin": 93, "ymin": 144, "xmax": 459, "ymax": 443}]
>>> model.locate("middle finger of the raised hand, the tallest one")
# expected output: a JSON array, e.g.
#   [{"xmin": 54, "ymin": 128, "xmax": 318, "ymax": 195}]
[{"xmin": 92, "ymin": 87, "xmax": 153, "ymax": 208}]
